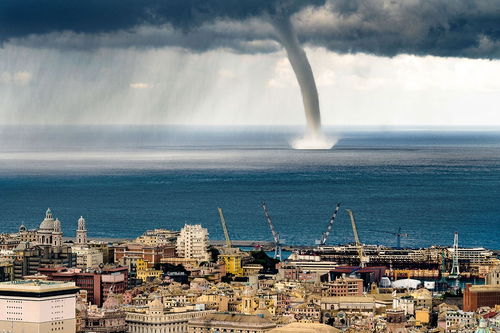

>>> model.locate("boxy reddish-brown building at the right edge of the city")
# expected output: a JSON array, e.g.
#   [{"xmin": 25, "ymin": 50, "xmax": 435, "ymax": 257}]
[{"xmin": 463, "ymin": 283, "xmax": 500, "ymax": 311}]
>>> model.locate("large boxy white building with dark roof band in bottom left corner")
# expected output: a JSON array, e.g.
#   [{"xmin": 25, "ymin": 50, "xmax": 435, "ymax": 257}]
[{"xmin": 0, "ymin": 280, "xmax": 78, "ymax": 333}]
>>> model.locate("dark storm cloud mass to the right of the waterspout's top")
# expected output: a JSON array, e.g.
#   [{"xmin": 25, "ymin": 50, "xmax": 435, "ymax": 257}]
[{"xmin": 301, "ymin": 0, "xmax": 500, "ymax": 58}]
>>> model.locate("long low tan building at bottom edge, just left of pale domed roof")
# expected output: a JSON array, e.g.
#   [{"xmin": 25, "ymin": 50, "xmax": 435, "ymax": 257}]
[{"xmin": 188, "ymin": 312, "xmax": 276, "ymax": 333}]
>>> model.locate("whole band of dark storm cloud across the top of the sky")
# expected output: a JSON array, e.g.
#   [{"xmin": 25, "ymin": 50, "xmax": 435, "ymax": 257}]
[{"xmin": 0, "ymin": 0, "xmax": 500, "ymax": 58}]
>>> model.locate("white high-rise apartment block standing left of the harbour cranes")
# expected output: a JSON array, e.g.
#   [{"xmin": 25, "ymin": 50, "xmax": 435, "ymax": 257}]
[{"xmin": 176, "ymin": 224, "xmax": 210, "ymax": 261}]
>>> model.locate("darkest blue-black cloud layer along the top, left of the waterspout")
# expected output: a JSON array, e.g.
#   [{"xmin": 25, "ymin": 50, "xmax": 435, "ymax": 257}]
[{"xmin": 0, "ymin": 0, "xmax": 324, "ymax": 40}]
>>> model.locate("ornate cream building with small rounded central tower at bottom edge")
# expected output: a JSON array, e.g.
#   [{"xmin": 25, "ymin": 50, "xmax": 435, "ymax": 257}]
[{"xmin": 125, "ymin": 298, "xmax": 213, "ymax": 333}]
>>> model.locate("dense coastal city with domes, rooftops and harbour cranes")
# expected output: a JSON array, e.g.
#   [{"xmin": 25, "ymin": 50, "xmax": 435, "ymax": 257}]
[{"xmin": 0, "ymin": 208, "xmax": 500, "ymax": 333}]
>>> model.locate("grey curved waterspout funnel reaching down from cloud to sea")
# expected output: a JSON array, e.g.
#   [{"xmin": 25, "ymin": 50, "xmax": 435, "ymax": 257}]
[{"xmin": 271, "ymin": 16, "xmax": 321, "ymax": 136}]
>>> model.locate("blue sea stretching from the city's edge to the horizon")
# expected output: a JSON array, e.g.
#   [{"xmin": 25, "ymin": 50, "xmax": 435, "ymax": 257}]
[{"xmin": 0, "ymin": 126, "xmax": 500, "ymax": 249}]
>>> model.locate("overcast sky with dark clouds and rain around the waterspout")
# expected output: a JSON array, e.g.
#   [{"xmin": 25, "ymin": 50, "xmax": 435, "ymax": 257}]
[{"xmin": 0, "ymin": 0, "xmax": 500, "ymax": 126}]
